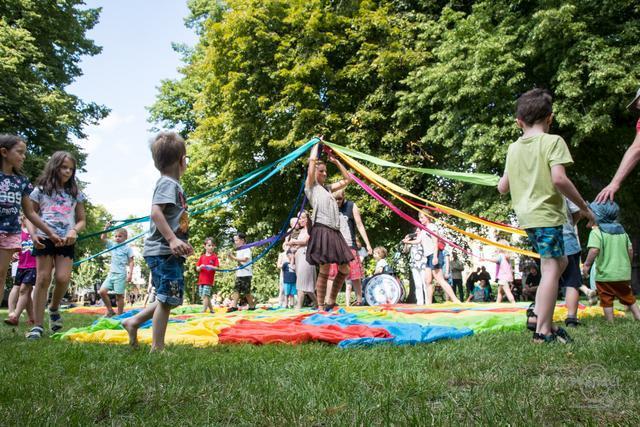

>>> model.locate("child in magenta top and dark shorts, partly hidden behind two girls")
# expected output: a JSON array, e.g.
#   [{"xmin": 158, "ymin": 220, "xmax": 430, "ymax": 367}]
[{"xmin": 4, "ymin": 216, "xmax": 36, "ymax": 326}]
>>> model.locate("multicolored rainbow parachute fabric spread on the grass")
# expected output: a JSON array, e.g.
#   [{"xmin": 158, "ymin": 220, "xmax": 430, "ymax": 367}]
[{"xmin": 54, "ymin": 303, "xmax": 619, "ymax": 348}]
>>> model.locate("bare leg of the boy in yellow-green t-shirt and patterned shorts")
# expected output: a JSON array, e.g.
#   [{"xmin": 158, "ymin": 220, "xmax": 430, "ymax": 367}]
[{"xmin": 535, "ymin": 256, "xmax": 567, "ymax": 335}]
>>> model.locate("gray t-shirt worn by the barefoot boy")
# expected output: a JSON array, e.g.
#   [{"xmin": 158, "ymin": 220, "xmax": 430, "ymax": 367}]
[{"xmin": 142, "ymin": 175, "xmax": 189, "ymax": 256}]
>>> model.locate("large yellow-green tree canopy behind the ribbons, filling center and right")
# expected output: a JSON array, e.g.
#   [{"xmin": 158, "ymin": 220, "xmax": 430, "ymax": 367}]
[{"xmin": 150, "ymin": 0, "xmax": 640, "ymax": 252}]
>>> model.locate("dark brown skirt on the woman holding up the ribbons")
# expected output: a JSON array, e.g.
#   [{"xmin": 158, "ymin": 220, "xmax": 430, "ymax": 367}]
[{"xmin": 307, "ymin": 223, "xmax": 353, "ymax": 265}]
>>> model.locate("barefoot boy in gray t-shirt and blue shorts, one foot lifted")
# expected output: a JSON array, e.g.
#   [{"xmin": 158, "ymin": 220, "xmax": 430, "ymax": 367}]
[{"xmin": 122, "ymin": 132, "xmax": 193, "ymax": 351}]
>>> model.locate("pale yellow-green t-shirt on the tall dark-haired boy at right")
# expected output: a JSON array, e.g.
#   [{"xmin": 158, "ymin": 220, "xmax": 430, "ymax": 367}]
[{"xmin": 505, "ymin": 133, "xmax": 573, "ymax": 228}]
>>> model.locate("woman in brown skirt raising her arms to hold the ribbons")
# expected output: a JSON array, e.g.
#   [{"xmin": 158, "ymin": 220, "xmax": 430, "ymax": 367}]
[{"xmin": 304, "ymin": 145, "xmax": 353, "ymax": 310}]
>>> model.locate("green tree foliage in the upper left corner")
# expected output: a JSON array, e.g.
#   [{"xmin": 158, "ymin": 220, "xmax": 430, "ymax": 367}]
[{"xmin": 0, "ymin": 0, "xmax": 108, "ymax": 179}]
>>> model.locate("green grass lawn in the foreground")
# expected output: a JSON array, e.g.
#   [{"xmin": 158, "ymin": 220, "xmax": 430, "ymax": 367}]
[{"xmin": 0, "ymin": 310, "xmax": 640, "ymax": 426}]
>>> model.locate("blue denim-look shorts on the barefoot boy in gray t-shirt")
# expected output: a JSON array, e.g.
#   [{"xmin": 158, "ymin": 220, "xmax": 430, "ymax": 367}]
[{"xmin": 144, "ymin": 255, "xmax": 184, "ymax": 307}]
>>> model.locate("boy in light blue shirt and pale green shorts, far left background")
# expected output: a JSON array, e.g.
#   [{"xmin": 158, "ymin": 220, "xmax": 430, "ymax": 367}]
[{"xmin": 98, "ymin": 222, "xmax": 133, "ymax": 317}]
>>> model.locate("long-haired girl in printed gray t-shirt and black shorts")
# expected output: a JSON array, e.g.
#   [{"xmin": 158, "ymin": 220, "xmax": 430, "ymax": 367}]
[{"xmin": 27, "ymin": 151, "xmax": 85, "ymax": 340}]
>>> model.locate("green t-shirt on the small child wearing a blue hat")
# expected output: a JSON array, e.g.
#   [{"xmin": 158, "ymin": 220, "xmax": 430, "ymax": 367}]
[{"xmin": 587, "ymin": 228, "xmax": 631, "ymax": 282}]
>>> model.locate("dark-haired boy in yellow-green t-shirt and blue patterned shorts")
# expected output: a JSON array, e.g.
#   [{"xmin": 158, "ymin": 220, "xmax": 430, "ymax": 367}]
[{"xmin": 498, "ymin": 89, "xmax": 594, "ymax": 343}]
